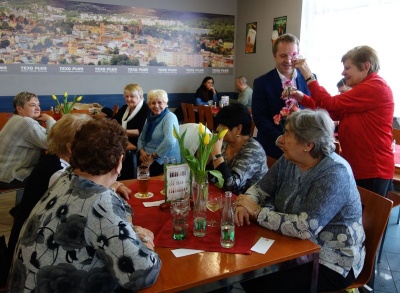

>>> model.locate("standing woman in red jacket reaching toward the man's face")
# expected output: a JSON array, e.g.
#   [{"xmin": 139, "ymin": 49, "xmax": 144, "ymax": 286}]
[{"xmin": 291, "ymin": 46, "xmax": 394, "ymax": 196}]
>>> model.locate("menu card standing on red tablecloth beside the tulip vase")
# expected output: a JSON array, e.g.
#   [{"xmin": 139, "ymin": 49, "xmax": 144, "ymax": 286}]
[{"xmin": 164, "ymin": 164, "xmax": 190, "ymax": 202}]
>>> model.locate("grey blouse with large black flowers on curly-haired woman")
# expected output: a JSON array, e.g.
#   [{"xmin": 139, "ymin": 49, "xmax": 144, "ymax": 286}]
[{"xmin": 10, "ymin": 168, "xmax": 161, "ymax": 293}]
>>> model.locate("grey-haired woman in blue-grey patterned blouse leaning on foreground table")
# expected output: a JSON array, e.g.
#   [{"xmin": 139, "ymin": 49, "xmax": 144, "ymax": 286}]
[{"xmin": 235, "ymin": 109, "xmax": 365, "ymax": 292}]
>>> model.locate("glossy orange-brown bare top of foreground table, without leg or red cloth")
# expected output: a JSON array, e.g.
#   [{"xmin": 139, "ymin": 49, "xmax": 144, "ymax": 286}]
[{"xmin": 122, "ymin": 176, "xmax": 320, "ymax": 292}]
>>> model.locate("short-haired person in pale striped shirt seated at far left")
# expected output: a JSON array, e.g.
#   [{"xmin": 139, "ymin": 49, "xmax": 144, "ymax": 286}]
[{"xmin": 0, "ymin": 92, "xmax": 56, "ymax": 189}]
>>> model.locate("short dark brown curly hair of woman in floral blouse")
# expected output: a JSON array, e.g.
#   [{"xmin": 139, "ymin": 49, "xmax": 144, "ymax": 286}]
[{"xmin": 70, "ymin": 118, "xmax": 128, "ymax": 175}]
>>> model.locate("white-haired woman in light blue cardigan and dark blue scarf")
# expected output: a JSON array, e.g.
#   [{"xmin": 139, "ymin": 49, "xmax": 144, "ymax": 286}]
[{"xmin": 138, "ymin": 89, "xmax": 181, "ymax": 176}]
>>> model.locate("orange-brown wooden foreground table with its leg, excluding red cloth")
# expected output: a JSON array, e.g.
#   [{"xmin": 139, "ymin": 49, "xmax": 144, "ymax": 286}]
[{"xmin": 122, "ymin": 176, "xmax": 320, "ymax": 292}]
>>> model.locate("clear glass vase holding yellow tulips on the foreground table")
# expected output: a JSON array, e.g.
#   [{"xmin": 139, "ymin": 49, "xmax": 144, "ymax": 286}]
[{"xmin": 192, "ymin": 173, "xmax": 208, "ymax": 237}]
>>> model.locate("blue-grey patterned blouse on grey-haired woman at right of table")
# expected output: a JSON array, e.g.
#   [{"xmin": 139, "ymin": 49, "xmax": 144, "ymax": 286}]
[{"xmin": 246, "ymin": 153, "xmax": 365, "ymax": 277}]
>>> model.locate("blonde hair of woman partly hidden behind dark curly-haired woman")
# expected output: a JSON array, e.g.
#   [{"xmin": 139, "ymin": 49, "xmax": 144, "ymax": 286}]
[{"xmin": 47, "ymin": 114, "xmax": 92, "ymax": 156}]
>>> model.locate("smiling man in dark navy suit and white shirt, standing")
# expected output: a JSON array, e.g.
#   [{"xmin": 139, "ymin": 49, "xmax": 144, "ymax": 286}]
[{"xmin": 251, "ymin": 34, "xmax": 310, "ymax": 159}]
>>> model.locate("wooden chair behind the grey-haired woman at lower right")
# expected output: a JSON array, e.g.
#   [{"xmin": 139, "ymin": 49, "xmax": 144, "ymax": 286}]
[{"xmin": 347, "ymin": 187, "xmax": 392, "ymax": 289}]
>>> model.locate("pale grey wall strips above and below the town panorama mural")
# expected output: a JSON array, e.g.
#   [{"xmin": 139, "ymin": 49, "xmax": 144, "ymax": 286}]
[{"xmin": 0, "ymin": 0, "xmax": 237, "ymax": 96}]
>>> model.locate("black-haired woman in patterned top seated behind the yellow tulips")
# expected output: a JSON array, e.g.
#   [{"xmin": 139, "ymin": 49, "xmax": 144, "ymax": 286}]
[{"xmin": 208, "ymin": 103, "xmax": 268, "ymax": 194}]
